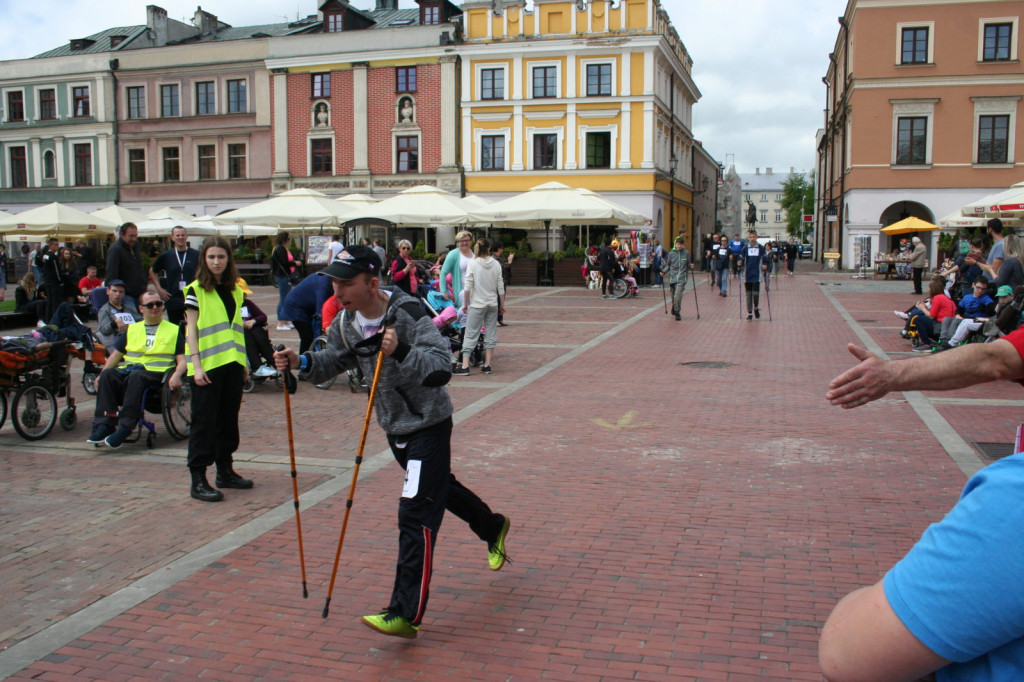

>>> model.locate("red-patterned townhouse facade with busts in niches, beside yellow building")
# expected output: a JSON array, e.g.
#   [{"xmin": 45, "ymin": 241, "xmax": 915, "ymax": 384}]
[{"xmin": 266, "ymin": 0, "xmax": 462, "ymax": 201}]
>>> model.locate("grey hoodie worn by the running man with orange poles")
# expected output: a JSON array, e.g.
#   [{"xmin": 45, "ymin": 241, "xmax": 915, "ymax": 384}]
[{"xmin": 302, "ymin": 287, "xmax": 453, "ymax": 436}]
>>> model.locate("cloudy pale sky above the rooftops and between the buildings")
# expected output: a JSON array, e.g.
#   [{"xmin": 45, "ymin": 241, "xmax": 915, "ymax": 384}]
[{"xmin": 0, "ymin": 0, "xmax": 847, "ymax": 173}]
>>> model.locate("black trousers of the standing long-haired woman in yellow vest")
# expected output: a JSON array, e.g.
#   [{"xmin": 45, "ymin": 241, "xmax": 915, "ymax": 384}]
[{"xmin": 188, "ymin": 363, "xmax": 245, "ymax": 471}]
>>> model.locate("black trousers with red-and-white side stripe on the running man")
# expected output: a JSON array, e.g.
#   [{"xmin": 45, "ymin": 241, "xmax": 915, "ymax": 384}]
[{"xmin": 387, "ymin": 417, "xmax": 505, "ymax": 625}]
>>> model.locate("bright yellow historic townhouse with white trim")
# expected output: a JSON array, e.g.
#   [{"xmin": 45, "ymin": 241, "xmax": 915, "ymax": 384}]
[{"xmin": 459, "ymin": 0, "xmax": 714, "ymax": 242}]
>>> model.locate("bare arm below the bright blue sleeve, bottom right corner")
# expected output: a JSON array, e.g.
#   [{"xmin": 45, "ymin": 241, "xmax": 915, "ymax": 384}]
[{"xmin": 818, "ymin": 581, "xmax": 949, "ymax": 682}]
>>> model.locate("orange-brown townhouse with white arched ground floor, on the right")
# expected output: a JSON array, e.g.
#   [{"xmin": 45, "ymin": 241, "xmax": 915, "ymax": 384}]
[{"xmin": 815, "ymin": 0, "xmax": 1024, "ymax": 267}]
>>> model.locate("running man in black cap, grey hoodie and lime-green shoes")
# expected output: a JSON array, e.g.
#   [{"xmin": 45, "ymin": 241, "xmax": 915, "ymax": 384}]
[{"xmin": 274, "ymin": 246, "xmax": 510, "ymax": 639}]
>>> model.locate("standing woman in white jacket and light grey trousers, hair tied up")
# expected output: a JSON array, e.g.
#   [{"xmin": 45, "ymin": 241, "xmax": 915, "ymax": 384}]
[{"xmin": 452, "ymin": 240, "xmax": 505, "ymax": 376}]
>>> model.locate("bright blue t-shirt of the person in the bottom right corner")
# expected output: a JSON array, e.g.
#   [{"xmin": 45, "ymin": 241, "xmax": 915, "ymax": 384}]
[{"xmin": 883, "ymin": 453, "xmax": 1024, "ymax": 682}]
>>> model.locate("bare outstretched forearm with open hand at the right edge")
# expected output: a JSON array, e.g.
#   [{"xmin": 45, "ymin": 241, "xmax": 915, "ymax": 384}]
[{"xmin": 825, "ymin": 340, "xmax": 1024, "ymax": 409}]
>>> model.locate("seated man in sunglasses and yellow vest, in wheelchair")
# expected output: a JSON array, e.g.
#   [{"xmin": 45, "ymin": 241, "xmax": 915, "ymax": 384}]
[{"xmin": 86, "ymin": 290, "xmax": 185, "ymax": 449}]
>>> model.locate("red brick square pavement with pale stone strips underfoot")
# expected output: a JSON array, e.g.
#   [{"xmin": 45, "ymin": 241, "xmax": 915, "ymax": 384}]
[{"xmin": 0, "ymin": 263, "xmax": 1024, "ymax": 682}]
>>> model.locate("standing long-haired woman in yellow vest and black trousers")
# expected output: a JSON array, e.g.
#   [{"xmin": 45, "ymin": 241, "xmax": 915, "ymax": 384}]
[{"xmin": 185, "ymin": 237, "xmax": 253, "ymax": 502}]
